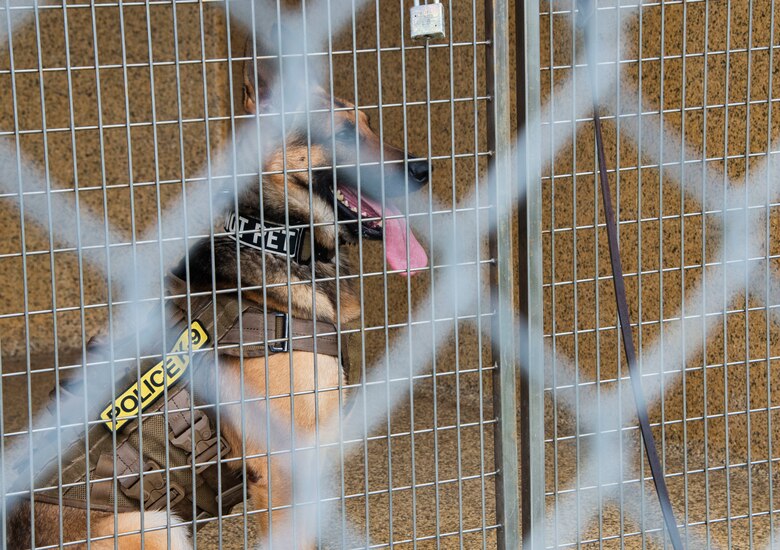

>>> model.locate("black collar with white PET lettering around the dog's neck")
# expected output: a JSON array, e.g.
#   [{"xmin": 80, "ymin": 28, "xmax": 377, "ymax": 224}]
[{"xmin": 225, "ymin": 212, "xmax": 333, "ymax": 264}]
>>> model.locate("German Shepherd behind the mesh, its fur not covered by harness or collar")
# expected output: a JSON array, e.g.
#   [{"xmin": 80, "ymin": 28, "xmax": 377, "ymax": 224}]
[{"xmin": 7, "ymin": 36, "xmax": 429, "ymax": 550}]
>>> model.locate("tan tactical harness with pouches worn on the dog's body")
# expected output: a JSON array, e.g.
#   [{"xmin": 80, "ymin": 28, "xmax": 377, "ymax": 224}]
[{"xmin": 29, "ymin": 276, "xmax": 348, "ymax": 520}]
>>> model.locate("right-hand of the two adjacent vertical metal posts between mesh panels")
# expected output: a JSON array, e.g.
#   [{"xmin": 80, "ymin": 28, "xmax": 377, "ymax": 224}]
[{"xmin": 515, "ymin": 0, "xmax": 545, "ymax": 549}]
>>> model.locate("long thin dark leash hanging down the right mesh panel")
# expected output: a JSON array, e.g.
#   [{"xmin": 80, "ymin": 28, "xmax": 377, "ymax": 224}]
[{"xmin": 578, "ymin": 0, "xmax": 683, "ymax": 550}]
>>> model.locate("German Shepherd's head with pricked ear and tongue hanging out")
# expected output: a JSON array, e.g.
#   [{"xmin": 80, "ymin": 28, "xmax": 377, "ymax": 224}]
[{"xmin": 242, "ymin": 36, "xmax": 429, "ymax": 270}]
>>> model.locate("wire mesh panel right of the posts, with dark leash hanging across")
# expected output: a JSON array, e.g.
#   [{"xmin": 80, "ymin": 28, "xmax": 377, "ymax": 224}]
[{"xmin": 534, "ymin": 0, "xmax": 780, "ymax": 548}]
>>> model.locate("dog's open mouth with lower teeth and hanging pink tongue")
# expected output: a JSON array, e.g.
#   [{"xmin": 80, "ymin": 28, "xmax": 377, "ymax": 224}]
[{"xmin": 336, "ymin": 184, "xmax": 428, "ymax": 275}]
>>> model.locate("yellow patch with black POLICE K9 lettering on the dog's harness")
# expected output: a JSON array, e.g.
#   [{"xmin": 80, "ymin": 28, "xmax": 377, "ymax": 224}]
[{"xmin": 100, "ymin": 321, "xmax": 209, "ymax": 431}]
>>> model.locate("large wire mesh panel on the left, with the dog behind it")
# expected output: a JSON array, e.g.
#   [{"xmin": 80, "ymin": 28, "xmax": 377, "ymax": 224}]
[{"xmin": 0, "ymin": 0, "xmax": 517, "ymax": 548}]
